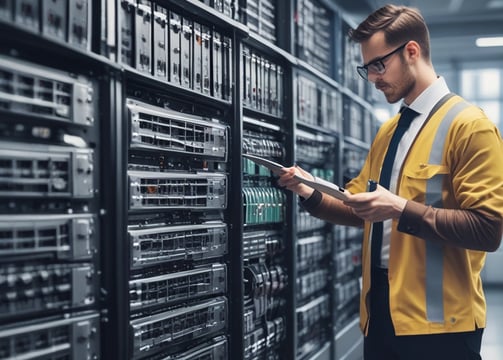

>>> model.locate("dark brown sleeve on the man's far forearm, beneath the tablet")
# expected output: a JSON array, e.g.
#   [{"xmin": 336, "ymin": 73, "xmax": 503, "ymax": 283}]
[{"xmin": 301, "ymin": 190, "xmax": 363, "ymax": 227}]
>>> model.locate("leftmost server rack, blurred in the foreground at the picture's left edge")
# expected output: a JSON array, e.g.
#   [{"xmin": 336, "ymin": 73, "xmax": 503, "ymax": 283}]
[{"xmin": 0, "ymin": 1, "xmax": 114, "ymax": 359}]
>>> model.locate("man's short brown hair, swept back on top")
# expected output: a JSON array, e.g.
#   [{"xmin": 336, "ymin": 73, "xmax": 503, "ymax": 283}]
[{"xmin": 349, "ymin": 4, "xmax": 430, "ymax": 60}]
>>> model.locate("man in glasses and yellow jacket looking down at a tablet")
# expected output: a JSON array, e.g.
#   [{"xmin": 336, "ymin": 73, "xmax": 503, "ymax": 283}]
[{"xmin": 278, "ymin": 5, "xmax": 503, "ymax": 360}]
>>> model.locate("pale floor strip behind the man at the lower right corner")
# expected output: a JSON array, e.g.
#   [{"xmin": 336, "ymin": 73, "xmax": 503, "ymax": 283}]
[{"xmin": 481, "ymin": 285, "xmax": 503, "ymax": 360}]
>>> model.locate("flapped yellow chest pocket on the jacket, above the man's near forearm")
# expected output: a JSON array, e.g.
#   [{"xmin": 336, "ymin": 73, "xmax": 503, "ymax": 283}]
[{"xmin": 400, "ymin": 164, "xmax": 449, "ymax": 206}]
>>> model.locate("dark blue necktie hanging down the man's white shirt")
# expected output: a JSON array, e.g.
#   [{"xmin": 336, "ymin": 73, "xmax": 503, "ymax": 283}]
[{"xmin": 371, "ymin": 107, "xmax": 419, "ymax": 267}]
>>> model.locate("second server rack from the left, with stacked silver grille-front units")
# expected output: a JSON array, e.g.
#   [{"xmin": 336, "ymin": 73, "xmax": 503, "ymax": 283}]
[{"xmin": 117, "ymin": 1, "xmax": 241, "ymax": 359}]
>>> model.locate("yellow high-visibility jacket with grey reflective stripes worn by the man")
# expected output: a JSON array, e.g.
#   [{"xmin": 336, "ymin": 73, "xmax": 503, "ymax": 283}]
[{"xmin": 346, "ymin": 96, "xmax": 503, "ymax": 335}]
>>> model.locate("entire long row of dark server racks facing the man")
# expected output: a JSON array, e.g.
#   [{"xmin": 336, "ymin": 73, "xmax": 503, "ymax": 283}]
[{"xmin": 0, "ymin": 0, "xmax": 373, "ymax": 360}]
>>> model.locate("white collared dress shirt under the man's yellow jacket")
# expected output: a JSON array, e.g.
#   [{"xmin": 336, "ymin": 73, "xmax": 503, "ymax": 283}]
[{"xmin": 381, "ymin": 77, "xmax": 450, "ymax": 268}]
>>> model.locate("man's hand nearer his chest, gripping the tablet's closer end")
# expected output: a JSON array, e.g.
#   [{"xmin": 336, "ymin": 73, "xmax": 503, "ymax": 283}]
[{"xmin": 344, "ymin": 185, "xmax": 407, "ymax": 222}]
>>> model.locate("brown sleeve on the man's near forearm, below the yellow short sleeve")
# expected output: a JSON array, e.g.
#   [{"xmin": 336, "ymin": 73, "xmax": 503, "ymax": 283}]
[{"xmin": 398, "ymin": 201, "xmax": 503, "ymax": 251}]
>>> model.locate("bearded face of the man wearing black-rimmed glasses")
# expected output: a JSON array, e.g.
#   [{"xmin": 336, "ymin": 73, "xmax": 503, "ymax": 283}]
[{"xmin": 361, "ymin": 32, "xmax": 416, "ymax": 104}]
